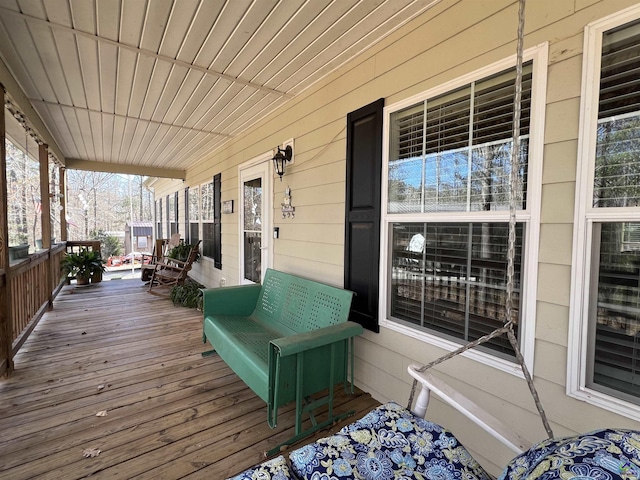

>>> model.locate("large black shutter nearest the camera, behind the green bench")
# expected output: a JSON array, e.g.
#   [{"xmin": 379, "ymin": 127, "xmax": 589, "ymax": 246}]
[{"xmin": 344, "ymin": 98, "xmax": 384, "ymax": 332}]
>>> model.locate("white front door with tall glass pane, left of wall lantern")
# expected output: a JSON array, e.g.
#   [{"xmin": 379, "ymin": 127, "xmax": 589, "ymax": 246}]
[{"xmin": 238, "ymin": 162, "xmax": 271, "ymax": 283}]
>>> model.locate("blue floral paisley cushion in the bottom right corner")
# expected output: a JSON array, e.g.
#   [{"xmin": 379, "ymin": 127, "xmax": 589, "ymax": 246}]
[{"xmin": 500, "ymin": 430, "xmax": 640, "ymax": 480}]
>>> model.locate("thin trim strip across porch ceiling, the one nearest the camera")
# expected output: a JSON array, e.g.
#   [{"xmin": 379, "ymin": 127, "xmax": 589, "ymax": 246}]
[{"xmin": 0, "ymin": 6, "xmax": 293, "ymax": 98}]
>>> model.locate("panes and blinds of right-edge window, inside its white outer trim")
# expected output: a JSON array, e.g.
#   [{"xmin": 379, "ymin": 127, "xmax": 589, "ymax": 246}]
[{"xmin": 586, "ymin": 16, "xmax": 640, "ymax": 404}]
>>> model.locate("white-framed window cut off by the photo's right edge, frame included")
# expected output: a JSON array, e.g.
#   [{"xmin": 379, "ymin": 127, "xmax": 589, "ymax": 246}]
[{"xmin": 567, "ymin": 7, "xmax": 640, "ymax": 419}]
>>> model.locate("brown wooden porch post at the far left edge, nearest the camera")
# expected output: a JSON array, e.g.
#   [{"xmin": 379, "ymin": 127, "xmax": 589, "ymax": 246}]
[{"xmin": 0, "ymin": 84, "xmax": 13, "ymax": 375}]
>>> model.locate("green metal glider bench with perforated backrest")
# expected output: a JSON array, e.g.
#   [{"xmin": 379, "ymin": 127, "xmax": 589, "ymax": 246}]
[{"xmin": 203, "ymin": 269, "xmax": 363, "ymax": 451}]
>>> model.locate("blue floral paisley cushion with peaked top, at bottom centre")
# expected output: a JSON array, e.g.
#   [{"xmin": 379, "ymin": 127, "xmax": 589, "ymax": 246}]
[{"xmin": 289, "ymin": 402, "xmax": 491, "ymax": 480}]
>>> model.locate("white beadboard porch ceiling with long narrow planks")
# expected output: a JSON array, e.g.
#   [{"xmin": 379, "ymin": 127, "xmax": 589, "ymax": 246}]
[{"xmin": 0, "ymin": 0, "xmax": 439, "ymax": 176}]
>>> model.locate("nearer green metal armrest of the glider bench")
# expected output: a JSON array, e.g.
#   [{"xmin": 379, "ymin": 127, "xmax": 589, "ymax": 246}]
[{"xmin": 271, "ymin": 321, "xmax": 364, "ymax": 357}]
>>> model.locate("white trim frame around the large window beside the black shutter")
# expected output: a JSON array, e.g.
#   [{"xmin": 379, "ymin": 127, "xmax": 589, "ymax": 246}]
[{"xmin": 378, "ymin": 42, "xmax": 549, "ymax": 378}]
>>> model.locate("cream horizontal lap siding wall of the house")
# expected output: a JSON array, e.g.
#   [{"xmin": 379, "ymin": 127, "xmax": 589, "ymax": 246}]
[{"xmin": 155, "ymin": 0, "xmax": 640, "ymax": 473}]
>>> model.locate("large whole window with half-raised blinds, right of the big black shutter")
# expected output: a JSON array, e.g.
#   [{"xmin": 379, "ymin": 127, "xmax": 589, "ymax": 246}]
[{"xmin": 381, "ymin": 47, "xmax": 546, "ymax": 371}]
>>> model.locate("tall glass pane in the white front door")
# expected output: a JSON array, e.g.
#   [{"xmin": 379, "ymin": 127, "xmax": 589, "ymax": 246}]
[{"xmin": 243, "ymin": 178, "xmax": 262, "ymax": 283}]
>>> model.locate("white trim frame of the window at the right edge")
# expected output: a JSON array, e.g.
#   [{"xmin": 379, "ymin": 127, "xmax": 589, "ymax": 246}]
[{"xmin": 566, "ymin": 5, "xmax": 640, "ymax": 420}]
